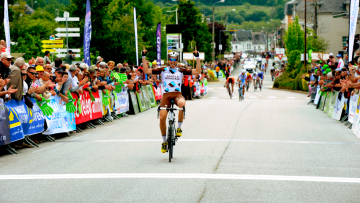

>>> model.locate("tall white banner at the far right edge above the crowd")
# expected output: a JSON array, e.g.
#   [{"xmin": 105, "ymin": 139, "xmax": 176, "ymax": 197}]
[{"xmin": 349, "ymin": 0, "xmax": 359, "ymax": 62}]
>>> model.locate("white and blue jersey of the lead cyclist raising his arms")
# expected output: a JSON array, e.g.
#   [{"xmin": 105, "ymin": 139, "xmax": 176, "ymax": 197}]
[{"xmin": 152, "ymin": 67, "xmax": 192, "ymax": 93}]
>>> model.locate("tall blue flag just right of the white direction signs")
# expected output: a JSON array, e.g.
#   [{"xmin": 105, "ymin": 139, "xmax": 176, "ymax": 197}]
[{"xmin": 83, "ymin": 0, "xmax": 91, "ymax": 67}]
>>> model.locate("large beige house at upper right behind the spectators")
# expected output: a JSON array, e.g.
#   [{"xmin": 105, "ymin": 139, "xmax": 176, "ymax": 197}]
[{"xmin": 283, "ymin": 0, "xmax": 360, "ymax": 54}]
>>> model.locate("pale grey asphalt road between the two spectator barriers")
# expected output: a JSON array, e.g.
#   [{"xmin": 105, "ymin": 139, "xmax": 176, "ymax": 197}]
[{"xmin": 0, "ymin": 63, "xmax": 360, "ymax": 203}]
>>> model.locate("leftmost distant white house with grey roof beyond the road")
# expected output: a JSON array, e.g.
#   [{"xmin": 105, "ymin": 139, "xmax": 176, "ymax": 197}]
[{"xmin": 230, "ymin": 30, "xmax": 253, "ymax": 53}]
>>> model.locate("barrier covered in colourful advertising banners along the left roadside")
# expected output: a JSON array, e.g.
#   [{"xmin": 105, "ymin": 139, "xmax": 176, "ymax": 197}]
[{"xmin": 0, "ymin": 79, "xmax": 207, "ymax": 154}]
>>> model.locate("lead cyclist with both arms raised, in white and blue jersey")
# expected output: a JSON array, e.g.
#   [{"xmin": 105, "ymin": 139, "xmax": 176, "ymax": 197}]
[{"xmin": 141, "ymin": 47, "xmax": 201, "ymax": 153}]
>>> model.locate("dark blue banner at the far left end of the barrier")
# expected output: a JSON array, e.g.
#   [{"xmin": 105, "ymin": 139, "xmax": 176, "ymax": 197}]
[{"xmin": 0, "ymin": 104, "xmax": 11, "ymax": 146}]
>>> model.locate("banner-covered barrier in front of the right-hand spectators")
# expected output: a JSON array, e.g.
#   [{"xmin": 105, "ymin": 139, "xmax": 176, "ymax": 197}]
[{"xmin": 313, "ymin": 87, "xmax": 360, "ymax": 138}]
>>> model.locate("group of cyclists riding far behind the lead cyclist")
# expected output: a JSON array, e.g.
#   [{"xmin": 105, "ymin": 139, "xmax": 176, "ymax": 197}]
[{"xmin": 224, "ymin": 69, "xmax": 264, "ymax": 99}]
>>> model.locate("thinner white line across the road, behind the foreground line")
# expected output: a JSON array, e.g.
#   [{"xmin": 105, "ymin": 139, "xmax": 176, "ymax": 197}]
[{"xmin": 57, "ymin": 138, "xmax": 360, "ymax": 145}]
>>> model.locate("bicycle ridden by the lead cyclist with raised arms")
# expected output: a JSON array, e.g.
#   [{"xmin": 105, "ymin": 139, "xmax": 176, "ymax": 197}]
[{"xmin": 157, "ymin": 100, "xmax": 185, "ymax": 162}]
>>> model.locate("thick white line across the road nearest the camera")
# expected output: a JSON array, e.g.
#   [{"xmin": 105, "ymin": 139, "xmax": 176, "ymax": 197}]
[{"xmin": 0, "ymin": 173, "xmax": 360, "ymax": 184}]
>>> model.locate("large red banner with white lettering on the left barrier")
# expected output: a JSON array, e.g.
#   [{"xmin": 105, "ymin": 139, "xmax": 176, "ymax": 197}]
[{"xmin": 72, "ymin": 91, "xmax": 102, "ymax": 125}]
